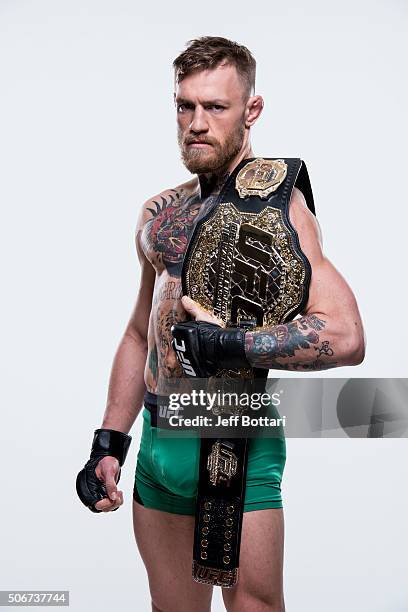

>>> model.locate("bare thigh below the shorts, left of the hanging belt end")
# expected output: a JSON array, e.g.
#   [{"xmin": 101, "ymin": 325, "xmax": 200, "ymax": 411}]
[{"xmin": 133, "ymin": 500, "xmax": 212, "ymax": 612}]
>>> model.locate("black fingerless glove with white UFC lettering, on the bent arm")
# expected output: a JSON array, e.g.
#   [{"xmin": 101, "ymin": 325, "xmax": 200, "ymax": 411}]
[{"xmin": 171, "ymin": 321, "xmax": 251, "ymax": 378}]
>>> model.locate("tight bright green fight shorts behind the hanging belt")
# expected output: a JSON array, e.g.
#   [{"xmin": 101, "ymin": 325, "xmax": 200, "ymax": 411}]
[{"xmin": 133, "ymin": 408, "xmax": 286, "ymax": 515}]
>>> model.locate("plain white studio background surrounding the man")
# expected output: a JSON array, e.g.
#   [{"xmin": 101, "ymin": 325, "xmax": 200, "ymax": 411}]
[{"xmin": 0, "ymin": 0, "xmax": 408, "ymax": 612}]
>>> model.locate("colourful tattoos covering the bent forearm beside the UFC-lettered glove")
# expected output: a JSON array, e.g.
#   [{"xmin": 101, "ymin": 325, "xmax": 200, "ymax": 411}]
[{"xmin": 245, "ymin": 315, "xmax": 337, "ymax": 371}]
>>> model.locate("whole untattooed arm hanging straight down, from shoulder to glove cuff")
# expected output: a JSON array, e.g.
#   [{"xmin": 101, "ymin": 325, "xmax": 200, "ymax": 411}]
[{"xmin": 101, "ymin": 224, "xmax": 155, "ymax": 433}]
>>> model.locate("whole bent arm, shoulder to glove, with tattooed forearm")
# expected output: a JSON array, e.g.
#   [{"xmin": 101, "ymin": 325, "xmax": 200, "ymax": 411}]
[{"xmin": 245, "ymin": 188, "xmax": 365, "ymax": 371}]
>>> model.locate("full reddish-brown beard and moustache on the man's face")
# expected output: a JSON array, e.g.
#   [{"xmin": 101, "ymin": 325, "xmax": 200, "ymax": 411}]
[{"xmin": 178, "ymin": 123, "xmax": 245, "ymax": 174}]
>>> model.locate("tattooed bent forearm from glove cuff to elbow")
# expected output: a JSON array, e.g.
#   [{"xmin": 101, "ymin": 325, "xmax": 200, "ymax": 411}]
[{"xmin": 245, "ymin": 314, "xmax": 364, "ymax": 371}]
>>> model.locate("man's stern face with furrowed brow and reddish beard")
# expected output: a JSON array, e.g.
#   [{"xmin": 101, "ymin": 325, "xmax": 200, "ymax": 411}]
[{"xmin": 175, "ymin": 64, "xmax": 247, "ymax": 174}]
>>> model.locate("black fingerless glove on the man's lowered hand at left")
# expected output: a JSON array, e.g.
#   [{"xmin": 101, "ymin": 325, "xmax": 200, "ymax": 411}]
[{"xmin": 76, "ymin": 429, "xmax": 132, "ymax": 512}]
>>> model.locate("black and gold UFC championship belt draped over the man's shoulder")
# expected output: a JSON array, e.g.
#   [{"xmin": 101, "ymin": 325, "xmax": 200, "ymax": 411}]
[{"xmin": 182, "ymin": 158, "xmax": 315, "ymax": 587}]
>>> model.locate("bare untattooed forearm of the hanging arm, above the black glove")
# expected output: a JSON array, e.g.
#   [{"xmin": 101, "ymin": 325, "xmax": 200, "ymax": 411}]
[{"xmin": 101, "ymin": 331, "xmax": 147, "ymax": 433}]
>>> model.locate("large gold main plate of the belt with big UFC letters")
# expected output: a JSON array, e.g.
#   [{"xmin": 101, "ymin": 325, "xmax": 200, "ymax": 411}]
[{"xmin": 185, "ymin": 202, "xmax": 306, "ymax": 329}]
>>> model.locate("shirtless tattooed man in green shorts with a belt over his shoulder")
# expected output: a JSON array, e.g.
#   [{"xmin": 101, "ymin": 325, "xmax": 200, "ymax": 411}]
[{"xmin": 75, "ymin": 37, "xmax": 364, "ymax": 612}]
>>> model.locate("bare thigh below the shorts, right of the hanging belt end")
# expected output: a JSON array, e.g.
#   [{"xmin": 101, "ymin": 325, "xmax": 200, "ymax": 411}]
[{"xmin": 222, "ymin": 508, "xmax": 285, "ymax": 612}]
